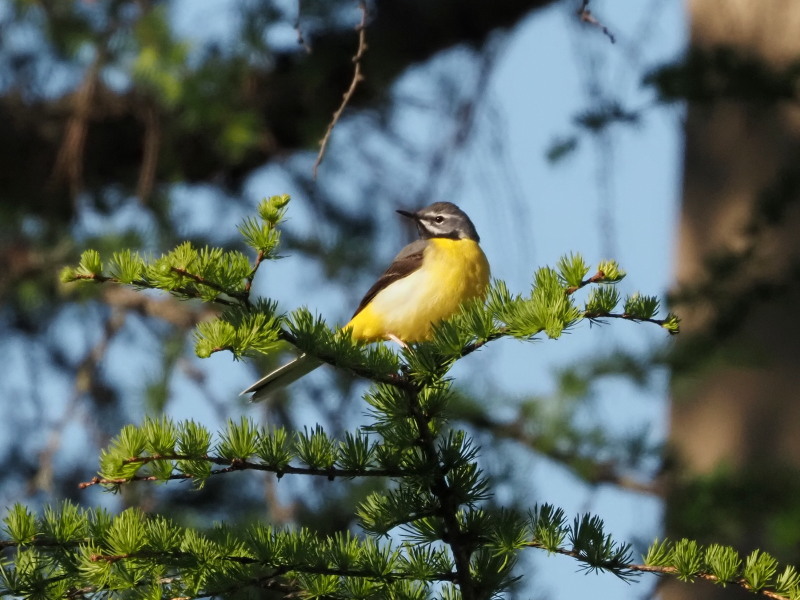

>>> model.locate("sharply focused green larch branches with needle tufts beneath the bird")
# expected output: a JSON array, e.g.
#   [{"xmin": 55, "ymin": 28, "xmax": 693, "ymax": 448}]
[{"xmin": 15, "ymin": 196, "xmax": 784, "ymax": 599}]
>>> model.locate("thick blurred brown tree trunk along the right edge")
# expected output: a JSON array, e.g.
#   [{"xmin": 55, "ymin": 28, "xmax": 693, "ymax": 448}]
[{"xmin": 662, "ymin": 0, "xmax": 800, "ymax": 599}]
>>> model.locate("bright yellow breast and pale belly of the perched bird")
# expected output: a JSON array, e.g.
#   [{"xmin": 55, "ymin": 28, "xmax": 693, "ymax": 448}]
[{"xmin": 347, "ymin": 238, "xmax": 490, "ymax": 343}]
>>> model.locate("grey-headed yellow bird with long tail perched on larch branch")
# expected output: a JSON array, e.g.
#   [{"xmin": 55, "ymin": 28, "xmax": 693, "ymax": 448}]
[{"xmin": 242, "ymin": 202, "xmax": 489, "ymax": 402}]
